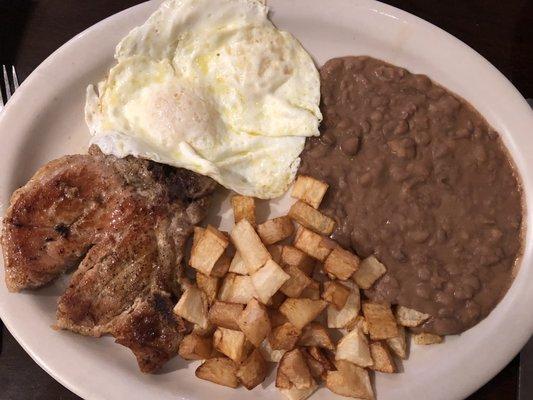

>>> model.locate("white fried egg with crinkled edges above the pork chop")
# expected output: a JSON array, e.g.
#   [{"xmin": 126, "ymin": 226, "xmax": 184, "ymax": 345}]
[{"xmin": 85, "ymin": 0, "xmax": 322, "ymax": 199}]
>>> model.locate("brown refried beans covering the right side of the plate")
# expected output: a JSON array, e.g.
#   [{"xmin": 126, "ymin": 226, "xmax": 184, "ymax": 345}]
[{"xmin": 299, "ymin": 57, "xmax": 523, "ymax": 335}]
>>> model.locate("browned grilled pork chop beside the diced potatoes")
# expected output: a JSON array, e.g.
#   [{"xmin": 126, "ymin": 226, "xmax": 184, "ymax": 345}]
[{"xmin": 2, "ymin": 146, "xmax": 215, "ymax": 372}]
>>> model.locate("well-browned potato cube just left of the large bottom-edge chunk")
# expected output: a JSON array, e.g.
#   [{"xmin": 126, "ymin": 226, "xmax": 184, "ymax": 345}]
[{"xmin": 276, "ymin": 349, "xmax": 316, "ymax": 389}]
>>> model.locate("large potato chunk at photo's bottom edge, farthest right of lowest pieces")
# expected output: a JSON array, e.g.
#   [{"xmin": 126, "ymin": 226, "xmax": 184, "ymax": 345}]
[{"xmin": 326, "ymin": 361, "xmax": 374, "ymax": 400}]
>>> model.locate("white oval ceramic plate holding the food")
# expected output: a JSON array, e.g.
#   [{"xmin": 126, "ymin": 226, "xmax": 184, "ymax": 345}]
[{"xmin": 0, "ymin": 0, "xmax": 533, "ymax": 400}]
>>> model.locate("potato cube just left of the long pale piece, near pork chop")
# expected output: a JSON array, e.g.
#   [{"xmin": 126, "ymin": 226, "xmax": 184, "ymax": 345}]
[{"xmin": 189, "ymin": 225, "xmax": 229, "ymax": 275}]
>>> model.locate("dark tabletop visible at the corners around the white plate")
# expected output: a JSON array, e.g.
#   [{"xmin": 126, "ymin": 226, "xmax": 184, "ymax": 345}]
[{"xmin": 0, "ymin": 0, "xmax": 533, "ymax": 400}]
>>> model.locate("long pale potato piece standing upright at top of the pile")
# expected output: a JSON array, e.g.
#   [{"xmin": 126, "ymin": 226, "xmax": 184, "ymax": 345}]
[{"xmin": 230, "ymin": 219, "xmax": 270, "ymax": 274}]
